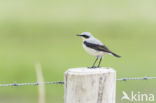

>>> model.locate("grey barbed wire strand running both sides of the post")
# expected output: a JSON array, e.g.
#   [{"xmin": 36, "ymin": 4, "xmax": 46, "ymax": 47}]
[{"xmin": 0, "ymin": 76, "xmax": 156, "ymax": 87}]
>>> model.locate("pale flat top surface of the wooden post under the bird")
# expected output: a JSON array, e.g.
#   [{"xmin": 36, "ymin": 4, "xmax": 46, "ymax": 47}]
[{"xmin": 65, "ymin": 67, "xmax": 115, "ymax": 74}]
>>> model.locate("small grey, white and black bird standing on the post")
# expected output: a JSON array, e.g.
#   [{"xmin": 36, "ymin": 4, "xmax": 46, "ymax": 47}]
[{"xmin": 77, "ymin": 32, "xmax": 121, "ymax": 68}]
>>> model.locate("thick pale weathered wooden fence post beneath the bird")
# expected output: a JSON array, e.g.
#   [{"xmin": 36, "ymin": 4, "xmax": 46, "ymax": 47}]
[{"xmin": 64, "ymin": 68, "xmax": 116, "ymax": 103}]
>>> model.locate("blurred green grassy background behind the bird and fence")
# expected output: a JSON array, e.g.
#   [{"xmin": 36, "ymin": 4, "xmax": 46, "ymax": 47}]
[{"xmin": 0, "ymin": 0, "xmax": 156, "ymax": 103}]
